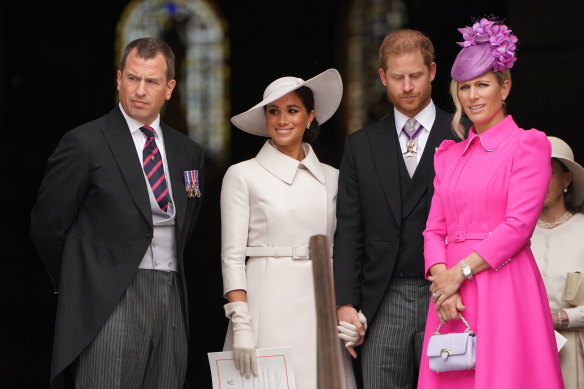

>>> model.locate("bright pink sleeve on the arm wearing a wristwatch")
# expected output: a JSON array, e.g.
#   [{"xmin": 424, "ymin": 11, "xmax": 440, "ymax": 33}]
[{"xmin": 474, "ymin": 129, "xmax": 551, "ymax": 270}]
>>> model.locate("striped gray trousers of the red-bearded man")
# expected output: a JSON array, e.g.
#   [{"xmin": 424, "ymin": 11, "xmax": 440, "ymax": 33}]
[{"xmin": 360, "ymin": 278, "xmax": 430, "ymax": 389}]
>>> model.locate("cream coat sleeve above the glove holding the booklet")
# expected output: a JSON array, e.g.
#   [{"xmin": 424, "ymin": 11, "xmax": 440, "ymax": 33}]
[{"xmin": 221, "ymin": 164, "xmax": 250, "ymax": 294}]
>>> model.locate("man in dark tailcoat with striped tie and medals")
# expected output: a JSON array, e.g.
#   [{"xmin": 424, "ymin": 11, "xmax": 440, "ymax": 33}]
[{"xmin": 31, "ymin": 38, "xmax": 203, "ymax": 389}]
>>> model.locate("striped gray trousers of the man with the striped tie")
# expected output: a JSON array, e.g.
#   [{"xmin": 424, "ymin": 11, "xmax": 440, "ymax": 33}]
[{"xmin": 75, "ymin": 269, "xmax": 188, "ymax": 389}]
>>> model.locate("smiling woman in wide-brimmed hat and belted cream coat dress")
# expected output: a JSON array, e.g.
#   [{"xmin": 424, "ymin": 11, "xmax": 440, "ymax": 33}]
[{"xmin": 221, "ymin": 69, "xmax": 355, "ymax": 389}]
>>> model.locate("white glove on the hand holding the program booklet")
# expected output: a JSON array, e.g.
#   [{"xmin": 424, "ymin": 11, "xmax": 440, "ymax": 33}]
[{"xmin": 223, "ymin": 301, "xmax": 258, "ymax": 378}]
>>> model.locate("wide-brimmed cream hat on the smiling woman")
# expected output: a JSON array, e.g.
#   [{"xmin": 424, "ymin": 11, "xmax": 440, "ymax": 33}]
[{"xmin": 231, "ymin": 69, "xmax": 343, "ymax": 136}]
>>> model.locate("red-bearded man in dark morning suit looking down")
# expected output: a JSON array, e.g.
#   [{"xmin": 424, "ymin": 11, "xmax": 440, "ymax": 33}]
[{"xmin": 334, "ymin": 30, "xmax": 453, "ymax": 389}]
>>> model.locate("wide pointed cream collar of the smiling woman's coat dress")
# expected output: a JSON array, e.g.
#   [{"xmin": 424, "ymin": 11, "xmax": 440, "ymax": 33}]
[{"xmin": 255, "ymin": 140, "xmax": 325, "ymax": 184}]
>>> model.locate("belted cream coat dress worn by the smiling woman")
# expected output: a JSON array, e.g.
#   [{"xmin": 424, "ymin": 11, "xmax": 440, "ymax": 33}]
[{"xmin": 221, "ymin": 140, "xmax": 355, "ymax": 389}]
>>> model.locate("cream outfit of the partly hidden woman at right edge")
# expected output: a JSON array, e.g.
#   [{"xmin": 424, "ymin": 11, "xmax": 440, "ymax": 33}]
[{"xmin": 531, "ymin": 213, "xmax": 584, "ymax": 389}]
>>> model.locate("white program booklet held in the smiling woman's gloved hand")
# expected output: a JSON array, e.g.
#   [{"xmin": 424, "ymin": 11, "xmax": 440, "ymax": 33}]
[{"xmin": 208, "ymin": 347, "xmax": 296, "ymax": 389}]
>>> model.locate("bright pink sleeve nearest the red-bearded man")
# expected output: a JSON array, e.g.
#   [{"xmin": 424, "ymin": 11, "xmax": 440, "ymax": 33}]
[{"xmin": 423, "ymin": 140, "xmax": 456, "ymax": 277}]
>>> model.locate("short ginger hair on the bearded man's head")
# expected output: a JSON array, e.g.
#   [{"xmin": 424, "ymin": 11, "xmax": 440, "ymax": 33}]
[{"xmin": 379, "ymin": 29, "xmax": 435, "ymax": 71}]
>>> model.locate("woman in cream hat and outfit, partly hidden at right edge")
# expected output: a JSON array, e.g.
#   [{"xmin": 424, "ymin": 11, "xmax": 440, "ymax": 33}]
[{"xmin": 531, "ymin": 136, "xmax": 584, "ymax": 389}]
